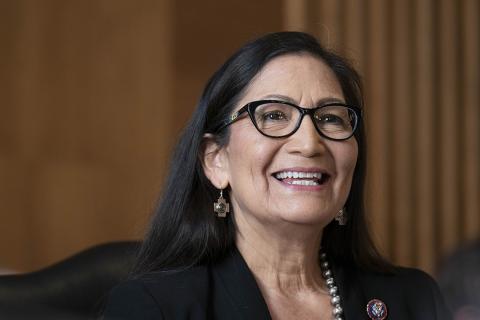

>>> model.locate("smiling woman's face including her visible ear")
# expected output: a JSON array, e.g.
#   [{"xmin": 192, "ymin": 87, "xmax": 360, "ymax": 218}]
[{"xmin": 204, "ymin": 53, "xmax": 358, "ymax": 235}]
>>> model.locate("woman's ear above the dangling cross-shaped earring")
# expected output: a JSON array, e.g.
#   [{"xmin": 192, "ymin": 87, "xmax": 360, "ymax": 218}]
[{"xmin": 200, "ymin": 133, "xmax": 228, "ymax": 189}]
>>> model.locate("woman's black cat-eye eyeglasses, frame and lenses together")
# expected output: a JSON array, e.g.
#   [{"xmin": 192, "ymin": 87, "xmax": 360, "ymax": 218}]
[{"xmin": 218, "ymin": 100, "xmax": 362, "ymax": 141}]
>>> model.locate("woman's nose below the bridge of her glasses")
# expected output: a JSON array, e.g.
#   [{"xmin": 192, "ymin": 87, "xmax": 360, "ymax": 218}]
[{"xmin": 287, "ymin": 115, "xmax": 326, "ymax": 157}]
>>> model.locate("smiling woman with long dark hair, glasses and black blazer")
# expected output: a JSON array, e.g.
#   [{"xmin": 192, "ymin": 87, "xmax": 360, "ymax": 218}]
[{"xmin": 105, "ymin": 32, "xmax": 448, "ymax": 320}]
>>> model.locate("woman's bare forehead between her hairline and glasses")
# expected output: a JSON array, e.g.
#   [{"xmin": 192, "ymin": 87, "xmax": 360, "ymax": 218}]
[{"xmin": 238, "ymin": 54, "xmax": 343, "ymax": 105}]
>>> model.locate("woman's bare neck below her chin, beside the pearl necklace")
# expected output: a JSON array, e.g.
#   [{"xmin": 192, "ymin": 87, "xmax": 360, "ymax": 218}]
[{"xmin": 236, "ymin": 215, "xmax": 325, "ymax": 296}]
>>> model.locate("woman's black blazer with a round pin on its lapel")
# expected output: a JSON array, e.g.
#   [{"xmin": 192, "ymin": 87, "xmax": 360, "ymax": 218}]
[{"xmin": 104, "ymin": 250, "xmax": 451, "ymax": 320}]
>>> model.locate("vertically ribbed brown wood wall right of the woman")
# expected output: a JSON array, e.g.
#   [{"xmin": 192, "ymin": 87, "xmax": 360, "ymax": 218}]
[{"xmin": 284, "ymin": 0, "xmax": 480, "ymax": 272}]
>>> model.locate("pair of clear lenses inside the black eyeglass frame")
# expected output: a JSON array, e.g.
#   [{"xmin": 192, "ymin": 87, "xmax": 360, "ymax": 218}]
[{"xmin": 254, "ymin": 103, "xmax": 356, "ymax": 140}]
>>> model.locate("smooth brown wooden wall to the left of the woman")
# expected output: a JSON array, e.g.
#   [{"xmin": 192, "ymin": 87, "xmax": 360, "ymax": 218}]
[{"xmin": 0, "ymin": 0, "xmax": 284, "ymax": 271}]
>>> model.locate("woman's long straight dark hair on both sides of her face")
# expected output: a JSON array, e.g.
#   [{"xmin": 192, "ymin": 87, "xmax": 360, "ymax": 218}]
[{"xmin": 133, "ymin": 32, "xmax": 386, "ymax": 276}]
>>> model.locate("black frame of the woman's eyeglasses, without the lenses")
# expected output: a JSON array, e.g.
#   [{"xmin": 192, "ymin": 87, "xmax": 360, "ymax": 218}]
[{"xmin": 217, "ymin": 100, "xmax": 363, "ymax": 141}]
